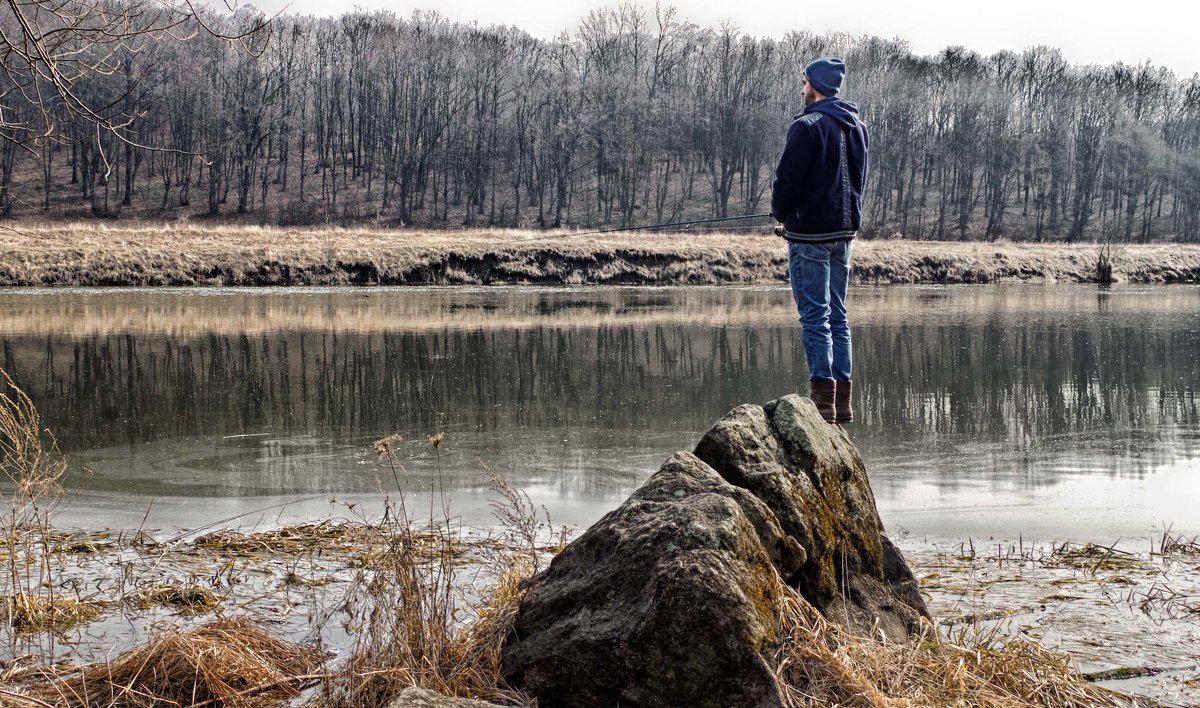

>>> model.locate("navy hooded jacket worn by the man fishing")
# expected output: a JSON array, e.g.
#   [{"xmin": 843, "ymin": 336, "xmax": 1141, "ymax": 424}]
[{"xmin": 770, "ymin": 97, "xmax": 870, "ymax": 244}]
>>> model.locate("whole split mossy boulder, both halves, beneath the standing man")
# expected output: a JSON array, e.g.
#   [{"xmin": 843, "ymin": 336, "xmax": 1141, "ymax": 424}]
[{"xmin": 502, "ymin": 396, "xmax": 928, "ymax": 708}]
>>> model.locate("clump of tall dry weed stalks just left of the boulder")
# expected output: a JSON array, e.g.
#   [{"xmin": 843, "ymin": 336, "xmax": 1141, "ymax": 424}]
[{"xmin": 319, "ymin": 434, "xmax": 536, "ymax": 706}]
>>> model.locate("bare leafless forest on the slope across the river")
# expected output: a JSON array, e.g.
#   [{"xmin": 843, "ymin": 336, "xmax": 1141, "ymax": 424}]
[{"xmin": 0, "ymin": 0, "xmax": 1200, "ymax": 242}]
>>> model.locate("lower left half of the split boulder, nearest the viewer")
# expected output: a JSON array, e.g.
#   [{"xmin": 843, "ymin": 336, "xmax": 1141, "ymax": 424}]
[{"xmin": 502, "ymin": 452, "xmax": 804, "ymax": 707}]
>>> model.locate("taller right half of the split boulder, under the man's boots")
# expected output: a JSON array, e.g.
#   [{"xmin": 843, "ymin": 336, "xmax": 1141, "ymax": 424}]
[{"xmin": 696, "ymin": 396, "xmax": 929, "ymax": 641}]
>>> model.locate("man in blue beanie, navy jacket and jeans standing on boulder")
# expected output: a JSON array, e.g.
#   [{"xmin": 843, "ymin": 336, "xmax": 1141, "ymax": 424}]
[{"xmin": 770, "ymin": 59, "xmax": 869, "ymax": 424}]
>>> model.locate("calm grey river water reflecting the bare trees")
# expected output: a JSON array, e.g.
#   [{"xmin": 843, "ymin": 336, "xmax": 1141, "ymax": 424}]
[{"xmin": 0, "ymin": 284, "xmax": 1200, "ymax": 541}]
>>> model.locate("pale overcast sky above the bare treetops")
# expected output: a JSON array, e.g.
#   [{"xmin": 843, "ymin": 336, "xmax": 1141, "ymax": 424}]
[{"xmin": 247, "ymin": 0, "xmax": 1200, "ymax": 77}]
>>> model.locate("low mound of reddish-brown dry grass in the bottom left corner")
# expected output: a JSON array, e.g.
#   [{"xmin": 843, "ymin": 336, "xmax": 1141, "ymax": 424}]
[{"xmin": 30, "ymin": 619, "xmax": 322, "ymax": 708}]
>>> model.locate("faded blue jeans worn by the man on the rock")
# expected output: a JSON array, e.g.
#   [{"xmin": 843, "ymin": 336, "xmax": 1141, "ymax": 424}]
[{"xmin": 787, "ymin": 239, "xmax": 852, "ymax": 382}]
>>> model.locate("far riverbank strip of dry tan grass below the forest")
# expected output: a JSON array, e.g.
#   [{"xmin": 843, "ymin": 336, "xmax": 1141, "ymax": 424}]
[{"xmin": 0, "ymin": 223, "xmax": 1200, "ymax": 287}]
